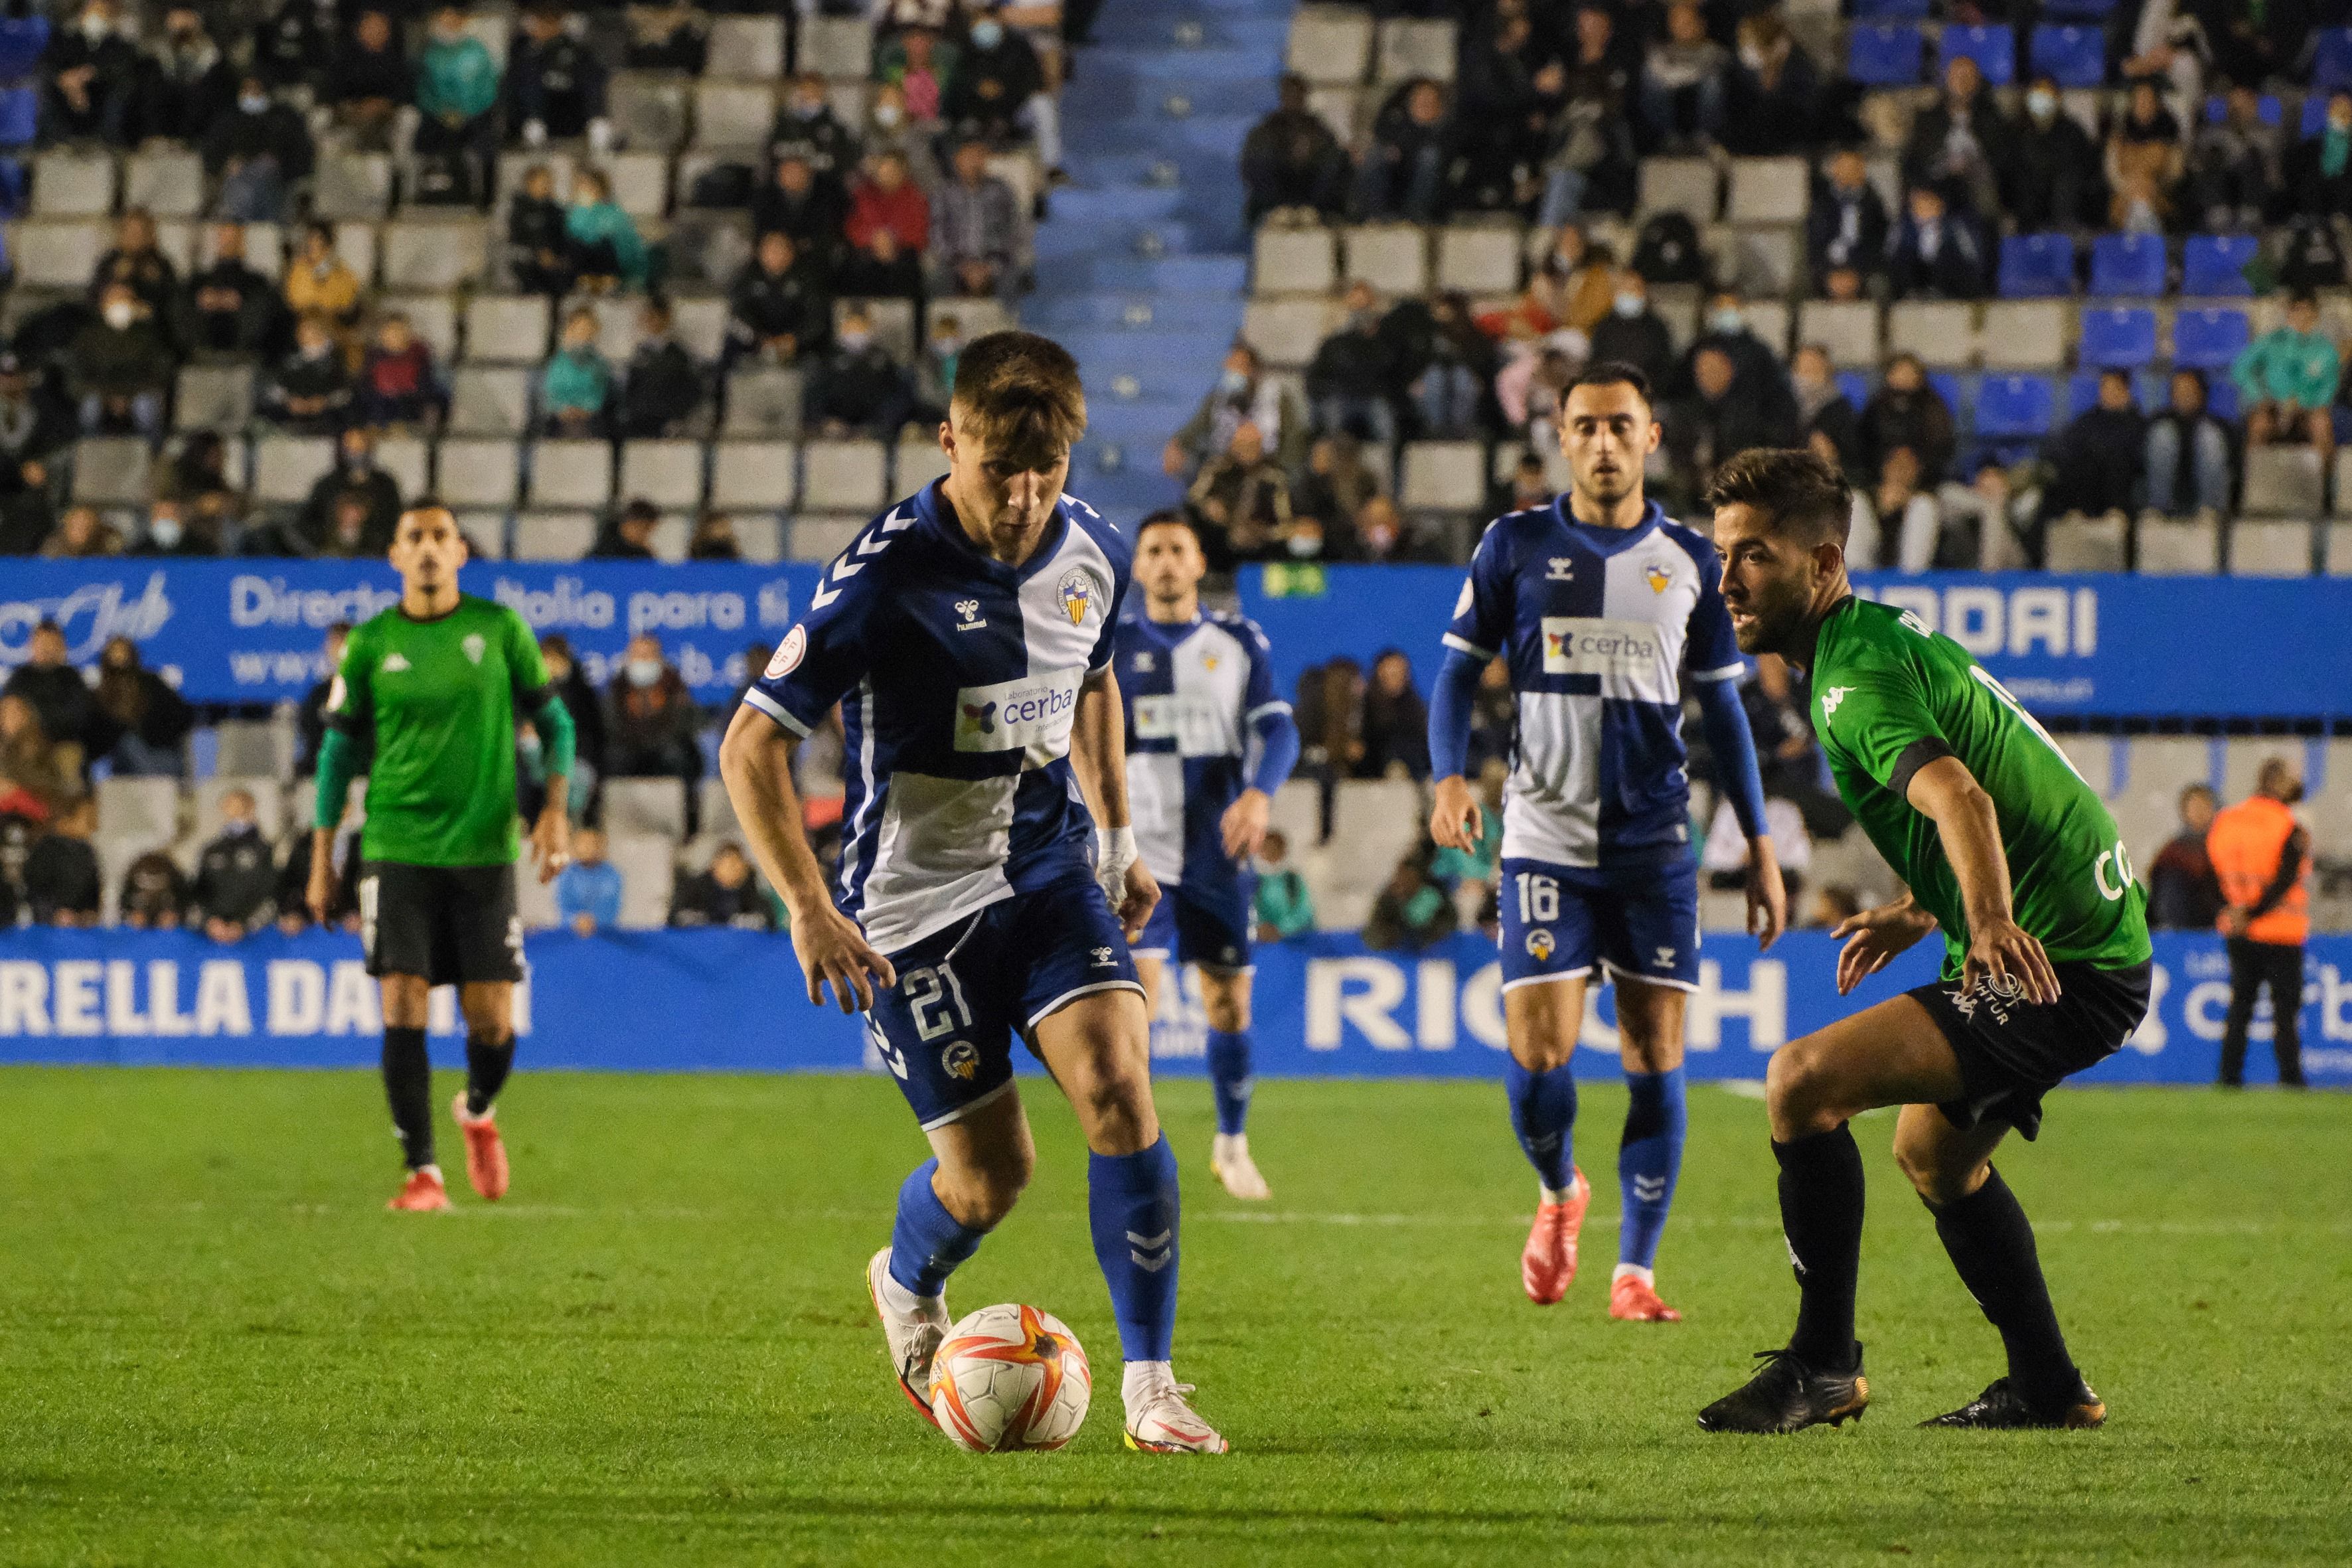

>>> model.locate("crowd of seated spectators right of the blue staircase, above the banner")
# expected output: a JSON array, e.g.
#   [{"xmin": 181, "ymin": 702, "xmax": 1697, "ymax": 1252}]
[{"xmin": 1214, "ymin": 0, "xmax": 2352, "ymax": 572}]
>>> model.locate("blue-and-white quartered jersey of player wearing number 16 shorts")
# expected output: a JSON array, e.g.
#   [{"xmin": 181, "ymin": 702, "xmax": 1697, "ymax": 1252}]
[{"xmin": 1444, "ymin": 496, "xmax": 1741, "ymax": 865}]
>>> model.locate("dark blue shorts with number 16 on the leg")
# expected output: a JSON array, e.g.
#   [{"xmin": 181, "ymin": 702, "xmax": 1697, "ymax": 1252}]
[{"xmin": 1496, "ymin": 848, "xmax": 1698, "ymax": 992}]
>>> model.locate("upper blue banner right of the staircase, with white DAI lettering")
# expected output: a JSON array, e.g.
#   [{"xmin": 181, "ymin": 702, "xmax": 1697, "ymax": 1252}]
[{"xmin": 1242, "ymin": 566, "xmax": 2352, "ymax": 720}]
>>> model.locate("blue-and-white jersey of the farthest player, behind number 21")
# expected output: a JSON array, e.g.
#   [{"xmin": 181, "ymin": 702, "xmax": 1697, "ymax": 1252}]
[{"xmin": 1113, "ymin": 607, "xmax": 1291, "ymax": 886}]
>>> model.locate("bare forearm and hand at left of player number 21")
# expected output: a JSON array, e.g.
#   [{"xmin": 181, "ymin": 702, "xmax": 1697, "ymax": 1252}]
[{"xmin": 720, "ymin": 703, "xmax": 898, "ymax": 1013}]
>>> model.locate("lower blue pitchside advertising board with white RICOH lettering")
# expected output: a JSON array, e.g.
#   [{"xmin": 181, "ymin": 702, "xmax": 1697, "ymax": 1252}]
[{"xmin": 0, "ymin": 929, "xmax": 2352, "ymax": 1086}]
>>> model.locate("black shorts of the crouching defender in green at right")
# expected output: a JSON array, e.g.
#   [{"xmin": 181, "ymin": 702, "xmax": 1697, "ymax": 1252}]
[{"xmin": 1905, "ymin": 961, "xmax": 2150, "ymax": 1138}]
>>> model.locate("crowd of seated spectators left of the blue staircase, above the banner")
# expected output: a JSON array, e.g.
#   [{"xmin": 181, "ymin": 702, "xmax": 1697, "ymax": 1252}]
[{"xmin": 0, "ymin": 0, "xmax": 1077, "ymax": 555}]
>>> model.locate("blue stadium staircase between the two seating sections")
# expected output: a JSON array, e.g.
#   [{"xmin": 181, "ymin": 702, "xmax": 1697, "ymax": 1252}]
[{"xmin": 1021, "ymin": 0, "xmax": 1291, "ymax": 522}]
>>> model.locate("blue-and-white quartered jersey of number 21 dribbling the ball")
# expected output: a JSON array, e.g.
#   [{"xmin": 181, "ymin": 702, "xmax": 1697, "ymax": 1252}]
[{"xmin": 744, "ymin": 482, "xmax": 1131, "ymax": 952}]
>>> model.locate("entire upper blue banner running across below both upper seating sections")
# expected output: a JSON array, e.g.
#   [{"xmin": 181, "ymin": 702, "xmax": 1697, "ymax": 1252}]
[{"xmin": 0, "ymin": 557, "xmax": 2352, "ymax": 720}]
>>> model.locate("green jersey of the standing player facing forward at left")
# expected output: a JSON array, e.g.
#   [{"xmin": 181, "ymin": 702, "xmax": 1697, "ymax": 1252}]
[{"xmin": 327, "ymin": 595, "xmax": 548, "ymax": 865}]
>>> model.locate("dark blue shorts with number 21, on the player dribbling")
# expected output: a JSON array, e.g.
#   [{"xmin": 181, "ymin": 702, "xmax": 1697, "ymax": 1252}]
[{"xmin": 866, "ymin": 874, "xmax": 1143, "ymax": 1131}]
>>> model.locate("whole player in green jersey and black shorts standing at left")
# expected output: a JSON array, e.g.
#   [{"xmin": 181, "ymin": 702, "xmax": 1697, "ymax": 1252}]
[{"xmin": 308, "ymin": 503, "xmax": 574, "ymax": 1211}]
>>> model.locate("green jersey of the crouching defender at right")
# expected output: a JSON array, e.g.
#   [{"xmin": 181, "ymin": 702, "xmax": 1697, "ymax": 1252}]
[{"xmin": 1814, "ymin": 599, "xmax": 2150, "ymax": 978}]
